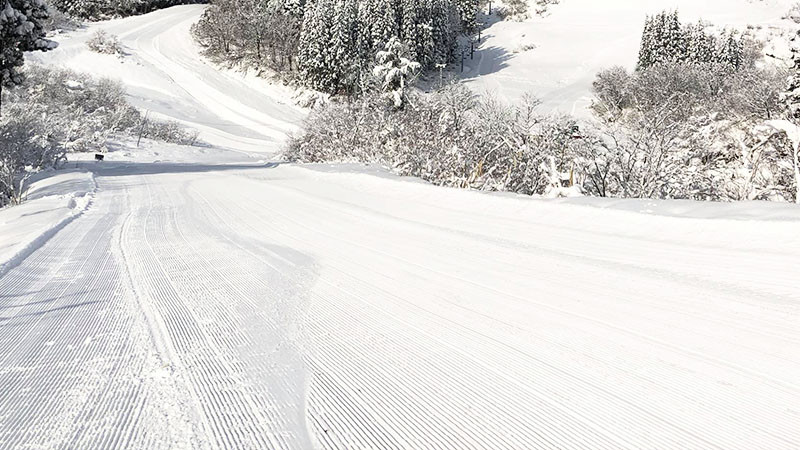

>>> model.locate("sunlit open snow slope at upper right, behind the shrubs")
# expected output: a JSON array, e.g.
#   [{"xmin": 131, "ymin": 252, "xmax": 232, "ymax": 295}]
[{"xmin": 465, "ymin": 0, "xmax": 797, "ymax": 117}]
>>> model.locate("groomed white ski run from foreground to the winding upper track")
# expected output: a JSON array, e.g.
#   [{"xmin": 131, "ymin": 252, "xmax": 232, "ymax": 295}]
[{"xmin": 0, "ymin": 0, "xmax": 800, "ymax": 450}]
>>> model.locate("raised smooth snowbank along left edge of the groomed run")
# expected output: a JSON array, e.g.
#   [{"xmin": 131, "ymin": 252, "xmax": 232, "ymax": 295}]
[{"xmin": 0, "ymin": 170, "xmax": 97, "ymax": 277}]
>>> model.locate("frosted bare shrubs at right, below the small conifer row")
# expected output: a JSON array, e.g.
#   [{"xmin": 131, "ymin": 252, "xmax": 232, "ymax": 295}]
[{"xmin": 582, "ymin": 57, "xmax": 793, "ymax": 200}]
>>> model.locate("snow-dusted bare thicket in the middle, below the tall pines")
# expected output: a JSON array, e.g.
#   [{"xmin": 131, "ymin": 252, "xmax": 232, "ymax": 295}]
[{"xmin": 286, "ymin": 83, "xmax": 584, "ymax": 194}]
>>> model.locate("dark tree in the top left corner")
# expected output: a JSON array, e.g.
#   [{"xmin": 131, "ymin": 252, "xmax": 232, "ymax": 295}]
[{"xmin": 0, "ymin": 0, "xmax": 58, "ymax": 85}]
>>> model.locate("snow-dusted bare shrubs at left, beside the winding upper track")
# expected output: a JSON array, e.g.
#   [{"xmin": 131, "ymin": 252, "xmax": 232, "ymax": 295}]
[{"xmin": 0, "ymin": 65, "xmax": 197, "ymax": 206}]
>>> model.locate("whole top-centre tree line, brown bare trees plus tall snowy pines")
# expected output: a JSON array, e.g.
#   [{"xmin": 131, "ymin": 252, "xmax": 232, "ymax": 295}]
[{"xmin": 194, "ymin": 0, "xmax": 478, "ymax": 94}]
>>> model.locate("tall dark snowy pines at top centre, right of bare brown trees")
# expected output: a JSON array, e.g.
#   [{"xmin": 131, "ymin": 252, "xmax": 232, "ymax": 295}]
[{"xmin": 294, "ymin": 0, "xmax": 466, "ymax": 93}]
